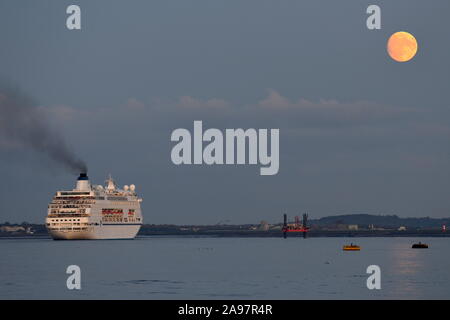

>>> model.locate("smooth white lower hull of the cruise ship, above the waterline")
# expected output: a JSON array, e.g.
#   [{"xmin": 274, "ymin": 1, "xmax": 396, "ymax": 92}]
[{"xmin": 48, "ymin": 224, "xmax": 141, "ymax": 240}]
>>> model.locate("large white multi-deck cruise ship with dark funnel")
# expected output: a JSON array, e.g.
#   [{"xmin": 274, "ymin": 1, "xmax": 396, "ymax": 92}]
[{"xmin": 46, "ymin": 173, "xmax": 143, "ymax": 240}]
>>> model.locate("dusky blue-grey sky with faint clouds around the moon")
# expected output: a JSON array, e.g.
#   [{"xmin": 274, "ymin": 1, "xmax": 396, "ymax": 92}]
[{"xmin": 0, "ymin": 0, "xmax": 450, "ymax": 223}]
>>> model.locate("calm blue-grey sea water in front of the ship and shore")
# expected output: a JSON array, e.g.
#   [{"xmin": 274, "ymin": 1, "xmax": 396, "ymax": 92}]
[{"xmin": 0, "ymin": 237, "xmax": 450, "ymax": 299}]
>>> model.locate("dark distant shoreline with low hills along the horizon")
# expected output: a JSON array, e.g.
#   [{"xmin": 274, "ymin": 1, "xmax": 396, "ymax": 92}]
[{"xmin": 0, "ymin": 214, "xmax": 450, "ymax": 238}]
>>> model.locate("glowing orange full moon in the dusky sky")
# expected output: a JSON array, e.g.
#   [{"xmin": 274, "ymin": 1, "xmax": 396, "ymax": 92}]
[{"xmin": 387, "ymin": 31, "xmax": 417, "ymax": 62}]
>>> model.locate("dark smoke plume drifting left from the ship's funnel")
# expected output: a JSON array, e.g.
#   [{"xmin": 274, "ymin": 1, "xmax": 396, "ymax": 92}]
[{"xmin": 0, "ymin": 84, "xmax": 87, "ymax": 173}]
